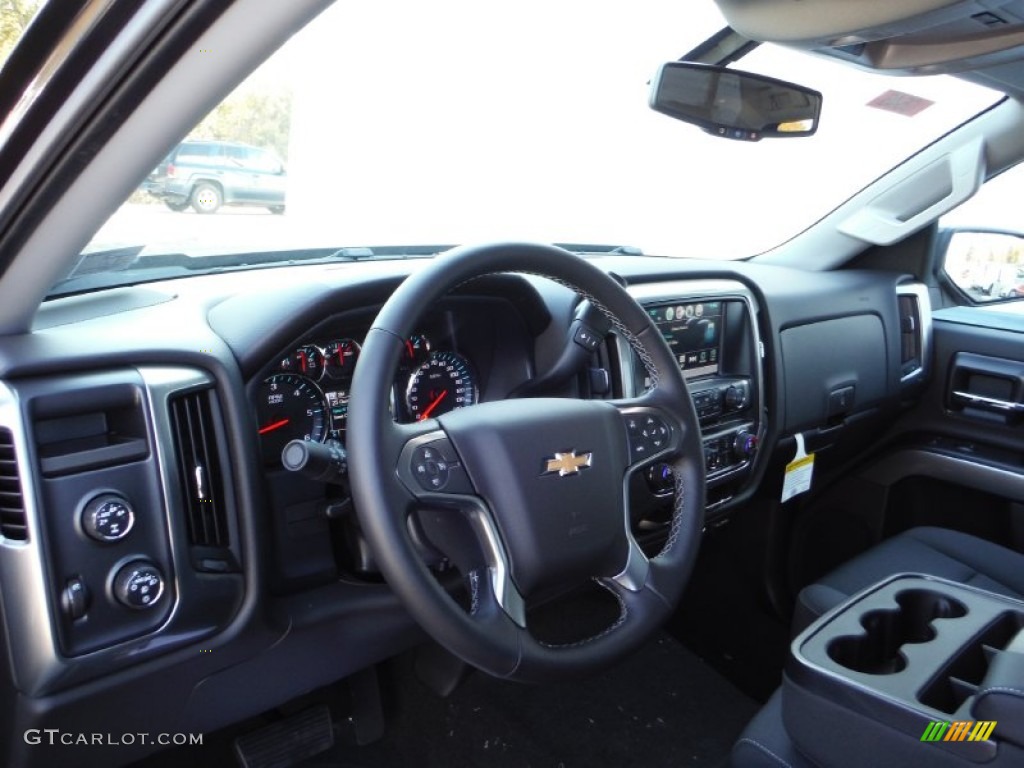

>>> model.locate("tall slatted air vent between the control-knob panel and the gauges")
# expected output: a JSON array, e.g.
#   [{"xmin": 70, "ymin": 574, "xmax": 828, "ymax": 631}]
[{"xmin": 170, "ymin": 389, "xmax": 230, "ymax": 548}]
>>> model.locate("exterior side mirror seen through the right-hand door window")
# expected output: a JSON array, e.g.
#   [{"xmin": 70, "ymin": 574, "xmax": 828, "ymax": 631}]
[{"xmin": 942, "ymin": 229, "xmax": 1024, "ymax": 303}]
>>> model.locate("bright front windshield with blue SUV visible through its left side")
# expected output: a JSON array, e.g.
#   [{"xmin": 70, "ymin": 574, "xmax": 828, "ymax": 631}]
[{"xmin": 70, "ymin": 0, "xmax": 999, "ymax": 292}]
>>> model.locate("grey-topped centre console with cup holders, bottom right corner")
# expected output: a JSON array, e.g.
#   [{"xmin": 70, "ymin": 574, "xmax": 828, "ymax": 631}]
[{"xmin": 783, "ymin": 573, "xmax": 1024, "ymax": 766}]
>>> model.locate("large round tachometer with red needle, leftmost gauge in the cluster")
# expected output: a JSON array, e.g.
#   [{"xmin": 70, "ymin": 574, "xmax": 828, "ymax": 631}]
[{"xmin": 256, "ymin": 374, "xmax": 330, "ymax": 462}]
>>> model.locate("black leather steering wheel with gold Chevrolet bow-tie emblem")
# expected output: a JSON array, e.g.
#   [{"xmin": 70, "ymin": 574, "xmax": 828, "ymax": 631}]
[{"xmin": 347, "ymin": 243, "xmax": 705, "ymax": 681}]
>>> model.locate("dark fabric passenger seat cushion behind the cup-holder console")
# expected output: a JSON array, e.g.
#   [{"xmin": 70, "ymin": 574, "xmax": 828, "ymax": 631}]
[{"xmin": 793, "ymin": 527, "xmax": 1024, "ymax": 633}]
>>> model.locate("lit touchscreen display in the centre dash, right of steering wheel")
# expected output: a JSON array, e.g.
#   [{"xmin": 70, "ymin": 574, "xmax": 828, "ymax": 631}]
[{"xmin": 647, "ymin": 301, "xmax": 723, "ymax": 379}]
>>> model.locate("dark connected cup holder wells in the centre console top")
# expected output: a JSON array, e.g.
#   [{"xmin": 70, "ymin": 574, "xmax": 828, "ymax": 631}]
[{"xmin": 827, "ymin": 590, "xmax": 967, "ymax": 675}]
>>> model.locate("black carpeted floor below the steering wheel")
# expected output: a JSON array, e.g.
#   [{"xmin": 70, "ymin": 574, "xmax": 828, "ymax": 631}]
[{"xmin": 319, "ymin": 635, "xmax": 757, "ymax": 768}]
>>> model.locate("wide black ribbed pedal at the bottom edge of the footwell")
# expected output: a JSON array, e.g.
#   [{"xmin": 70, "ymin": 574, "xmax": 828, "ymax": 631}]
[{"xmin": 234, "ymin": 707, "xmax": 334, "ymax": 768}]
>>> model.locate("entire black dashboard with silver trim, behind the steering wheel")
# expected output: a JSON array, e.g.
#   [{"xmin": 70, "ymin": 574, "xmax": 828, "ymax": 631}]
[{"xmin": 0, "ymin": 257, "xmax": 928, "ymax": 768}]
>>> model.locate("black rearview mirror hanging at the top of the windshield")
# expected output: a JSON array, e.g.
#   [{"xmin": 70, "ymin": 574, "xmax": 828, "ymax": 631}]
[{"xmin": 650, "ymin": 61, "xmax": 821, "ymax": 141}]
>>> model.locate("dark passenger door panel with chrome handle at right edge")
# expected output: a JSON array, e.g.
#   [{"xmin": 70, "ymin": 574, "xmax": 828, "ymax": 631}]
[{"xmin": 859, "ymin": 305, "xmax": 1024, "ymax": 546}]
